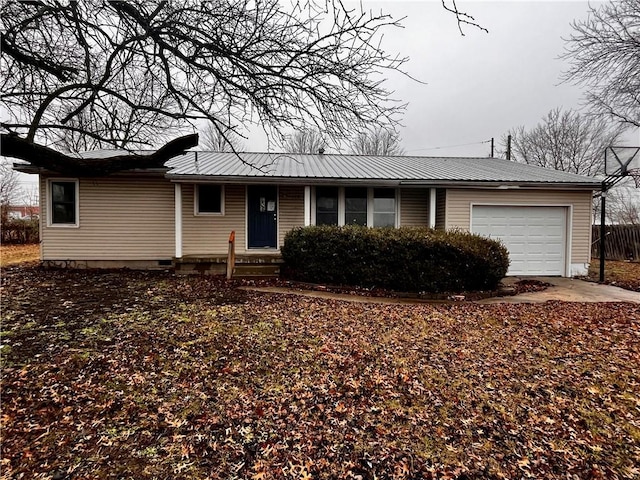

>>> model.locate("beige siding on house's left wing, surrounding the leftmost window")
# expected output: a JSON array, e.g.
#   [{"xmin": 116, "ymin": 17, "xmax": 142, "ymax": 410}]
[{"xmin": 40, "ymin": 176, "xmax": 175, "ymax": 260}]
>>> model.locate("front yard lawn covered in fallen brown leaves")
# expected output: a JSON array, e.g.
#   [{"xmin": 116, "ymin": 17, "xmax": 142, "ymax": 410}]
[{"xmin": 2, "ymin": 266, "xmax": 640, "ymax": 479}]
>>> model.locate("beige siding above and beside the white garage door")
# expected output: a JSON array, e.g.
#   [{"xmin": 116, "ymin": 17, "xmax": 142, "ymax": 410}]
[{"xmin": 445, "ymin": 189, "xmax": 592, "ymax": 263}]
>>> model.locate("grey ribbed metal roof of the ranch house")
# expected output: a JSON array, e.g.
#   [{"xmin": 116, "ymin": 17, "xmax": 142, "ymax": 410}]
[{"xmin": 166, "ymin": 152, "xmax": 600, "ymax": 188}]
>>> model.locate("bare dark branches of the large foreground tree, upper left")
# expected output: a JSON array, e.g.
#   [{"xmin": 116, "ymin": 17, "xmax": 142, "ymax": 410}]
[{"xmin": 0, "ymin": 0, "xmax": 478, "ymax": 169}]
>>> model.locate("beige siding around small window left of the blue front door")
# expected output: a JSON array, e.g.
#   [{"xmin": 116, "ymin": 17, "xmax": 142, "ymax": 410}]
[{"xmin": 182, "ymin": 184, "xmax": 246, "ymax": 256}]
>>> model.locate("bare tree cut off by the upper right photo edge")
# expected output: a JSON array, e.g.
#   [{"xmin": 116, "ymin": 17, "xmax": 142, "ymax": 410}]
[{"xmin": 563, "ymin": 0, "xmax": 640, "ymax": 127}]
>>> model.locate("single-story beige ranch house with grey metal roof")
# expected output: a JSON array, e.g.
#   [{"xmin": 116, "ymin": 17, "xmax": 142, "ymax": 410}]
[{"xmin": 17, "ymin": 151, "xmax": 600, "ymax": 277}]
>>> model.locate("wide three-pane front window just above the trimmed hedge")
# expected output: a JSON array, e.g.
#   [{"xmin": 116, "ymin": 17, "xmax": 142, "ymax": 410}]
[{"xmin": 312, "ymin": 187, "xmax": 398, "ymax": 227}]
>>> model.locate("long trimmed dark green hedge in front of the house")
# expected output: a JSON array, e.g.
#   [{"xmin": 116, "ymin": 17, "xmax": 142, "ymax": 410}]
[{"xmin": 281, "ymin": 226, "xmax": 509, "ymax": 293}]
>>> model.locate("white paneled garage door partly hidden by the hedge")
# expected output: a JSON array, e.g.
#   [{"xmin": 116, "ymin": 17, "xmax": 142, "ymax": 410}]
[{"xmin": 471, "ymin": 205, "xmax": 567, "ymax": 276}]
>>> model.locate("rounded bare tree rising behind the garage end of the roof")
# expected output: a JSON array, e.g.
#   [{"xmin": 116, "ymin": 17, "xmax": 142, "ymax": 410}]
[{"xmin": 501, "ymin": 108, "xmax": 623, "ymax": 176}]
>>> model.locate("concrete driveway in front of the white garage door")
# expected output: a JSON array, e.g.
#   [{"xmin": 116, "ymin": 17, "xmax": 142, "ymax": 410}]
[{"xmin": 476, "ymin": 277, "xmax": 640, "ymax": 304}]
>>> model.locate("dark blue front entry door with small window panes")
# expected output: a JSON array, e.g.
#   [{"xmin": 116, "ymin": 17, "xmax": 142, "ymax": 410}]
[{"xmin": 247, "ymin": 185, "xmax": 278, "ymax": 248}]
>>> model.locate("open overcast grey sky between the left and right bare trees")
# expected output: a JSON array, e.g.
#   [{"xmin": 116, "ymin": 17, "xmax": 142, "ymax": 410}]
[{"xmin": 376, "ymin": 1, "xmax": 640, "ymax": 156}]
